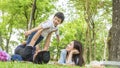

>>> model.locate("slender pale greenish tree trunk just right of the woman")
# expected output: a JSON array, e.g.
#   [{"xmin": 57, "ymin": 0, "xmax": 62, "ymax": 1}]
[{"xmin": 84, "ymin": 0, "xmax": 94, "ymax": 62}]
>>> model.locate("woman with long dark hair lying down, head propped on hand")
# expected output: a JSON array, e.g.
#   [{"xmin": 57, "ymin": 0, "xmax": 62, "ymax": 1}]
[{"xmin": 58, "ymin": 40, "xmax": 84, "ymax": 66}]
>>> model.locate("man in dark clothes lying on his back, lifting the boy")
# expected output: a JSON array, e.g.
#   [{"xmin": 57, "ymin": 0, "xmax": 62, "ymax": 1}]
[{"xmin": 12, "ymin": 32, "xmax": 52, "ymax": 64}]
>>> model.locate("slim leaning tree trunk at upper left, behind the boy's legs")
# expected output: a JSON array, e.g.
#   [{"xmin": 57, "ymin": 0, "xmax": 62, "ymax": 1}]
[{"xmin": 28, "ymin": 0, "xmax": 36, "ymax": 30}]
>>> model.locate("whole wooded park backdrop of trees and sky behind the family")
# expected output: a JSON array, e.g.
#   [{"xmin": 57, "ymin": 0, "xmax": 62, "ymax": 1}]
[{"xmin": 0, "ymin": 0, "xmax": 120, "ymax": 67}]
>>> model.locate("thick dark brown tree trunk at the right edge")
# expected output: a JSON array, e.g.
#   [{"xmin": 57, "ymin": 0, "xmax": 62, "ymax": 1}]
[{"xmin": 108, "ymin": 0, "xmax": 120, "ymax": 61}]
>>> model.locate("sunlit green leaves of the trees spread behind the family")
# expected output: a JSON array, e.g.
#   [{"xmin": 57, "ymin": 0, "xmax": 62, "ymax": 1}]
[{"xmin": 0, "ymin": 0, "xmax": 112, "ymax": 61}]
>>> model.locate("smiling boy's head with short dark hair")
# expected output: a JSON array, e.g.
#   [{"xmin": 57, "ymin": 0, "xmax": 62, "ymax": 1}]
[{"xmin": 53, "ymin": 12, "xmax": 65, "ymax": 26}]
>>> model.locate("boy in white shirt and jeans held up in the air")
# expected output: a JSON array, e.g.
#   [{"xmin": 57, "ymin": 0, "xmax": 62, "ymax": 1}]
[{"xmin": 25, "ymin": 12, "xmax": 64, "ymax": 50}]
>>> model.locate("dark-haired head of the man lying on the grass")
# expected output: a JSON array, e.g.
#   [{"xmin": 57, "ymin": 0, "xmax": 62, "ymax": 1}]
[{"xmin": 33, "ymin": 51, "xmax": 50, "ymax": 64}]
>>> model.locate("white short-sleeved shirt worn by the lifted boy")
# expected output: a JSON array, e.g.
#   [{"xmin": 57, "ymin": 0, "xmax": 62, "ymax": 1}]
[{"xmin": 40, "ymin": 21, "xmax": 59, "ymax": 37}]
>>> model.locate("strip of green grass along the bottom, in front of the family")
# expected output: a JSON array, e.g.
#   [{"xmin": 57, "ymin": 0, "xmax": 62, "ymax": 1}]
[{"xmin": 0, "ymin": 62, "xmax": 80, "ymax": 68}]
